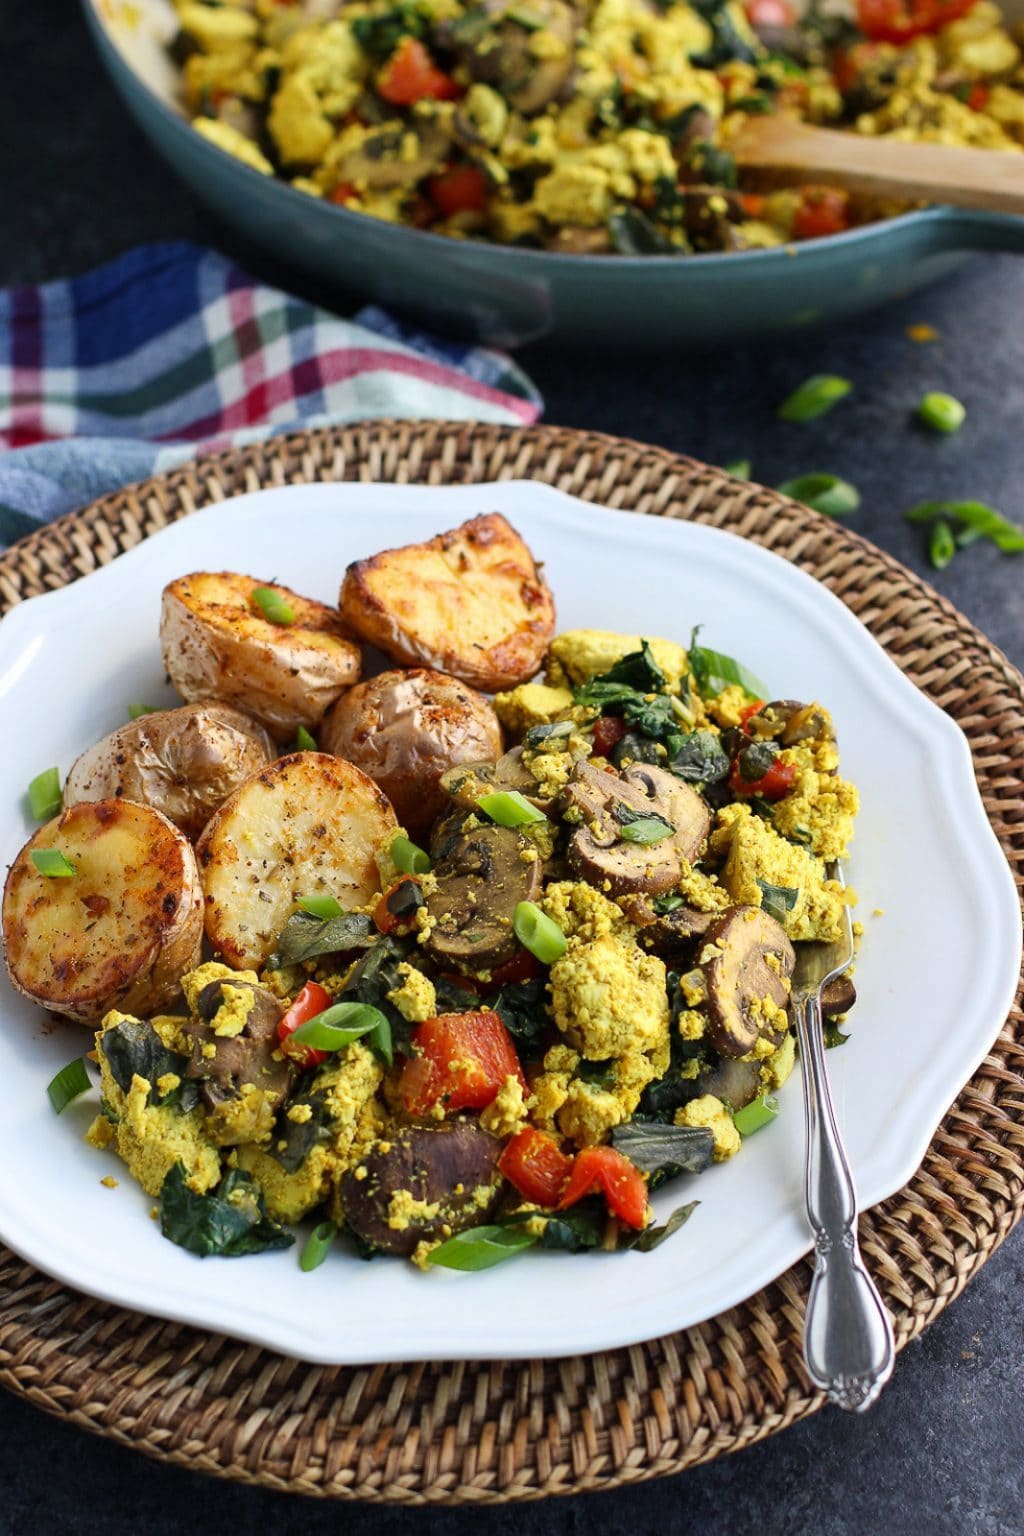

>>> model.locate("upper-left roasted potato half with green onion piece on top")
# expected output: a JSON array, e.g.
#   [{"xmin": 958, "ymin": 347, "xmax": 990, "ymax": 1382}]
[{"xmin": 160, "ymin": 571, "xmax": 361, "ymax": 742}]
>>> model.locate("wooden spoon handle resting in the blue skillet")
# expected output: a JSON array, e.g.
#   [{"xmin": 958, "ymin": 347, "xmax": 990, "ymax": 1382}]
[{"xmin": 729, "ymin": 117, "xmax": 1024, "ymax": 214}]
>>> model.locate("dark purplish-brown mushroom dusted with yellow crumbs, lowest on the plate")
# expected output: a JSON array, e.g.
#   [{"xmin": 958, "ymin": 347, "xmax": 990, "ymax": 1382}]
[{"xmin": 338, "ymin": 1120, "xmax": 502, "ymax": 1255}]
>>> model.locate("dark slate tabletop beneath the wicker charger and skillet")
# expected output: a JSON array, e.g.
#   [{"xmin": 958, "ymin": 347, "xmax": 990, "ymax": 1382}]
[{"xmin": 0, "ymin": 0, "xmax": 1024, "ymax": 1536}]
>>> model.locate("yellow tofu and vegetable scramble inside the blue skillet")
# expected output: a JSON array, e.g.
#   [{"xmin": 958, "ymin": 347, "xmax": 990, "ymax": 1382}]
[{"xmin": 173, "ymin": 0, "xmax": 1024, "ymax": 255}]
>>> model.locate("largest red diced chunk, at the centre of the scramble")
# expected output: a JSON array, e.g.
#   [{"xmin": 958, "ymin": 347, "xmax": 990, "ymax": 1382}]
[{"xmin": 399, "ymin": 1009, "xmax": 527, "ymax": 1115}]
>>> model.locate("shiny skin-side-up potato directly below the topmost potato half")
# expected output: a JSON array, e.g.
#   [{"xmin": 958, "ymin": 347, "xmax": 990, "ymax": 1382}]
[{"xmin": 321, "ymin": 667, "xmax": 502, "ymax": 836}]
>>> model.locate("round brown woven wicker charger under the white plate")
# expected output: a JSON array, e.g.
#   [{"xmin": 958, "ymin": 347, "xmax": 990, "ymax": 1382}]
[{"xmin": 0, "ymin": 422, "xmax": 1024, "ymax": 1504}]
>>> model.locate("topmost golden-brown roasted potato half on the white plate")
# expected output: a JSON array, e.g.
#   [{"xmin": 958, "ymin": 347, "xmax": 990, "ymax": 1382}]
[{"xmin": 339, "ymin": 511, "xmax": 554, "ymax": 693}]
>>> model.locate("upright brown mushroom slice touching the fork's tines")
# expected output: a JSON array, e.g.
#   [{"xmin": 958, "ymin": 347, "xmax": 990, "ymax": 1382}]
[{"xmin": 700, "ymin": 906, "xmax": 797, "ymax": 1057}]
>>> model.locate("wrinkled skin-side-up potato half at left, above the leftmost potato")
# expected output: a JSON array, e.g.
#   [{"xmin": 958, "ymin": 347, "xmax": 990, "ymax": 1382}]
[{"xmin": 64, "ymin": 703, "xmax": 275, "ymax": 842}]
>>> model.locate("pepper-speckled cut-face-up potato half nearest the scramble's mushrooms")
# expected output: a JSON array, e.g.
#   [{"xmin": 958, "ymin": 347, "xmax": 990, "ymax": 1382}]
[{"xmin": 197, "ymin": 753, "xmax": 398, "ymax": 971}]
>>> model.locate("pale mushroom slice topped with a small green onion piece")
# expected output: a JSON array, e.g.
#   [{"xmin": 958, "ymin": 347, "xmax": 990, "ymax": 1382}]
[{"xmin": 565, "ymin": 762, "xmax": 711, "ymax": 895}]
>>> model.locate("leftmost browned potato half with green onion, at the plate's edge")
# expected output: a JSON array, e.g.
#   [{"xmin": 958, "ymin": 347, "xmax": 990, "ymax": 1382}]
[{"xmin": 3, "ymin": 800, "xmax": 203, "ymax": 1025}]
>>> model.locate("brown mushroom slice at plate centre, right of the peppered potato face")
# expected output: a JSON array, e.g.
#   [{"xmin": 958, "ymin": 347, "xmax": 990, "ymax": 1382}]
[{"xmin": 425, "ymin": 826, "xmax": 542, "ymax": 971}]
